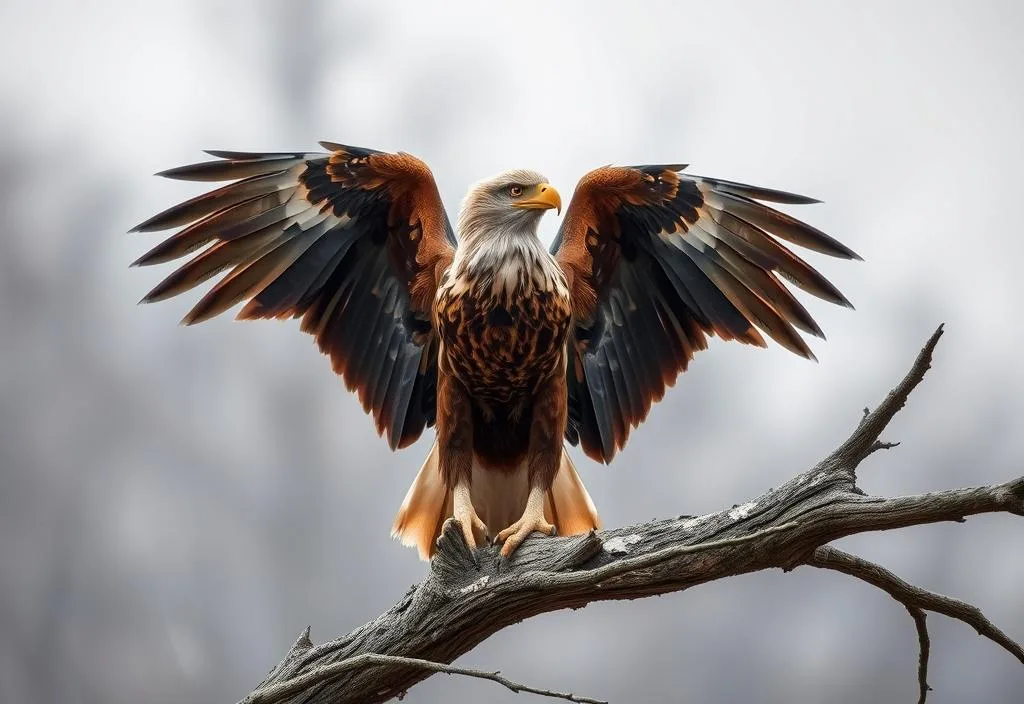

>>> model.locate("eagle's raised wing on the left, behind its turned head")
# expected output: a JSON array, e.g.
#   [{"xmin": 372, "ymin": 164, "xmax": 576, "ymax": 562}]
[{"xmin": 134, "ymin": 142, "xmax": 455, "ymax": 448}]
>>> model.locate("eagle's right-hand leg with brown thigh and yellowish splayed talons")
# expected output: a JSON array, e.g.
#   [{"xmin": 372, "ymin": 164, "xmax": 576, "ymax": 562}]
[{"xmin": 497, "ymin": 365, "xmax": 568, "ymax": 558}]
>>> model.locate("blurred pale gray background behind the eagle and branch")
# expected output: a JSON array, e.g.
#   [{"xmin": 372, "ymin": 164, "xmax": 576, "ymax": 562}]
[{"xmin": 0, "ymin": 0, "xmax": 1024, "ymax": 704}]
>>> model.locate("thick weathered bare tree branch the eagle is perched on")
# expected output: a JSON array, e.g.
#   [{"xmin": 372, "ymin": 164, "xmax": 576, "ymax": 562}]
[{"xmin": 239, "ymin": 327, "xmax": 1024, "ymax": 704}]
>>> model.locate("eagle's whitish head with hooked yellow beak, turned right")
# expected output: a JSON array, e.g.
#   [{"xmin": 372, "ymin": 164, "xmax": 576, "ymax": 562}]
[{"xmin": 459, "ymin": 169, "xmax": 562, "ymax": 241}]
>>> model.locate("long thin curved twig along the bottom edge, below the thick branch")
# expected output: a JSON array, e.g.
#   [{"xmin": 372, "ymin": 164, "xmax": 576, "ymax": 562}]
[{"xmin": 244, "ymin": 653, "xmax": 608, "ymax": 704}]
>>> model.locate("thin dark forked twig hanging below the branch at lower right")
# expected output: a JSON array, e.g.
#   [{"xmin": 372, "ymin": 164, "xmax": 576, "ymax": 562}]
[{"xmin": 807, "ymin": 545, "xmax": 1024, "ymax": 703}]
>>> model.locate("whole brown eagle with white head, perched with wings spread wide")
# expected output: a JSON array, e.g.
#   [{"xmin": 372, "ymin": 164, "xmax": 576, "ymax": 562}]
[{"xmin": 133, "ymin": 142, "xmax": 860, "ymax": 560}]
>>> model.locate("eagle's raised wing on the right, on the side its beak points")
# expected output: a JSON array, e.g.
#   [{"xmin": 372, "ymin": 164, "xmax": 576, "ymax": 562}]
[{"xmin": 552, "ymin": 165, "xmax": 859, "ymax": 461}]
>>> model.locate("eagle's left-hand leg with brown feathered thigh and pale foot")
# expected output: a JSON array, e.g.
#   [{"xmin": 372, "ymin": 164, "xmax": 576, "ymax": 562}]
[{"xmin": 437, "ymin": 366, "xmax": 487, "ymax": 549}]
